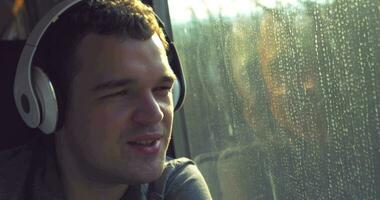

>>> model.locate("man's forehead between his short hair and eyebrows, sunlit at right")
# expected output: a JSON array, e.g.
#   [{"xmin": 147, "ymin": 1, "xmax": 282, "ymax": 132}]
[{"xmin": 76, "ymin": 34, "xmax": 174, "ymax": 84}]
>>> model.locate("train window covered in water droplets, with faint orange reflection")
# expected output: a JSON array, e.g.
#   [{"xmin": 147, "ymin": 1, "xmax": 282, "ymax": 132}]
[{"xmin": 168, "ymin": 0, "xmax": 380, "ymax": 200}]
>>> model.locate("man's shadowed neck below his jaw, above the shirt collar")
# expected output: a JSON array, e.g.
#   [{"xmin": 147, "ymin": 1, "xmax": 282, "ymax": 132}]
[{"xmin": 55, "ymin": 132, "xmax": 128, "ymax": 200}]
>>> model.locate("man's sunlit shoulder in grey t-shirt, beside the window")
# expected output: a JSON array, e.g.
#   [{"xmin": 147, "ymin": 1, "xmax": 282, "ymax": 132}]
[{"xmin": 148, "ymin": 158, "xmax": 211, "ymax": 200}]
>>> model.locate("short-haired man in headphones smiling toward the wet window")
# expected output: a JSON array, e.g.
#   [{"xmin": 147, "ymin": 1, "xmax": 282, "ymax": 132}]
[{"xmin": 0, "ymin": 0, "xmax": 211, "ymax": 200}]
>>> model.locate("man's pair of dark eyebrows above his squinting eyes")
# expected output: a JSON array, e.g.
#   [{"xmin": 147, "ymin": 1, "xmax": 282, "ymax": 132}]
[{"xmin": 91, "ymin": 73, "xmax": 177, "ymax": 92}]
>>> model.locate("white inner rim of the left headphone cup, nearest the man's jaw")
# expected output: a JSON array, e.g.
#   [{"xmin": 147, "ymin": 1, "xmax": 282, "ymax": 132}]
[{"xmin": 32, "ymin": 66, "xmax": 58, "ymax": 134}]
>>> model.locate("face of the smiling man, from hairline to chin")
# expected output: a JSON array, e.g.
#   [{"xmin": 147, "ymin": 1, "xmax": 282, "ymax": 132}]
[{"xmin": 57, "ymin": 34, "xmax": 175, "ymax": 184}]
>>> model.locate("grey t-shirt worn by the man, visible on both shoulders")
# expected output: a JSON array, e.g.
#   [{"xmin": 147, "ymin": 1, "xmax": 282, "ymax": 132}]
[{"xmin": 0, "ymin": 137, "xmax": 212, "ymax": 200}]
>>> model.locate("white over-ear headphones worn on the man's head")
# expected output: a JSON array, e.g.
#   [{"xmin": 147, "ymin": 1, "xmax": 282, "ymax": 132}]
[{"xmin": 13, "ymin": 0, "xmax": 185, "ymax": 134}]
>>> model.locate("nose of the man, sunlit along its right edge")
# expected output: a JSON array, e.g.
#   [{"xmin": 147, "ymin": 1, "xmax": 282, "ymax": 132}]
[{"xmin": 132, "ymin": 92, "xmax": 164, "ymax": 125}]
